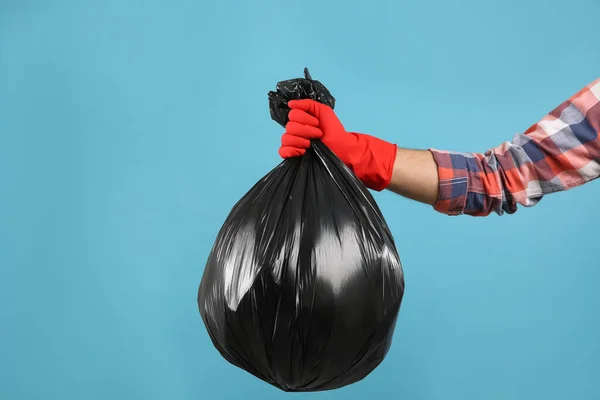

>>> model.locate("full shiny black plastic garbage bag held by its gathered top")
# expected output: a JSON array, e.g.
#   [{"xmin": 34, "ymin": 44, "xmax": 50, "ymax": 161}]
[{"xmin": 198, "ymin": 69, "xmax": 404, "ymax": 392}]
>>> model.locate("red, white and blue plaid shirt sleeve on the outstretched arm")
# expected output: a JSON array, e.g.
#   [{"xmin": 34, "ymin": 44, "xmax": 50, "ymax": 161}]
[{"xmin": 430, "ymin": 79, "xmax": 600, "ymax": 216}]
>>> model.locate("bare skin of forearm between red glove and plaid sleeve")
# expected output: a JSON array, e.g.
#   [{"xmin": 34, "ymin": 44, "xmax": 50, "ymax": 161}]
[{"xmin": 388, "ymin": 148, "xmax": 439, "ymax": 206}]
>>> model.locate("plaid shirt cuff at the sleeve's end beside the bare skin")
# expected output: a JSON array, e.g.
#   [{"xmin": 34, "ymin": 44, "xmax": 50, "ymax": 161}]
[{"xmin": 429, "ymin": 149, "xmax": 469, "ymax": 215}]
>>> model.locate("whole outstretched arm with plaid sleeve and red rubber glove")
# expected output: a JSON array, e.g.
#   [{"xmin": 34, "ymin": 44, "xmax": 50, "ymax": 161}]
[{"xmin": 280, "ymin": 80, "xmax": 600, "ymax": 216}]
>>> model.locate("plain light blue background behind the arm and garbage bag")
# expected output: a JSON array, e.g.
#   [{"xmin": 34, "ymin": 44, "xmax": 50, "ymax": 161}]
[{"xmin": 0, "ymin": 0, "xmax": 600, "ymax": 400}]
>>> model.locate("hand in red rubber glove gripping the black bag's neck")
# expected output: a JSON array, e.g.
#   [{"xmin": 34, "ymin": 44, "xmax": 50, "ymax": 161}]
[{"xmin": 279, "ymin": 100, "xmax": 397, "ymax": 191}]
